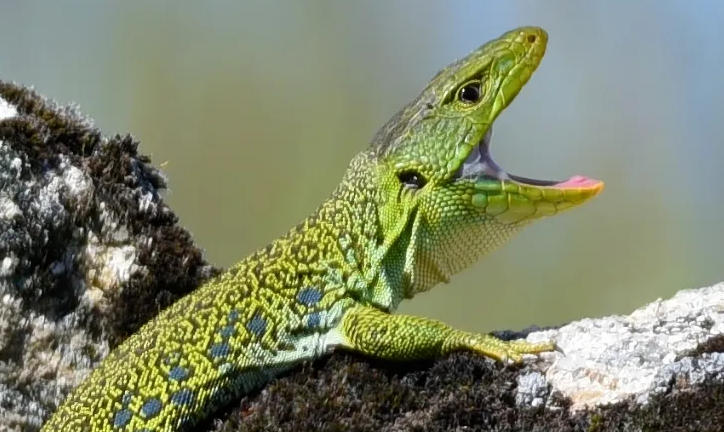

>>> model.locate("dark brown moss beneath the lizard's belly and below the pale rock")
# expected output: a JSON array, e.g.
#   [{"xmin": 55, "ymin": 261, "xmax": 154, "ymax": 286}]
[{"xmin": 189, "ymin": 353, "xmax": 724, "ymax": 432}]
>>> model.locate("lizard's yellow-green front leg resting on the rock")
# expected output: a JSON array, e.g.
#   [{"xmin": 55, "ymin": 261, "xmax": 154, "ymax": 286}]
[{"xmin": 337, "ymin": 305, "xmax": 556, "ymax": 363}]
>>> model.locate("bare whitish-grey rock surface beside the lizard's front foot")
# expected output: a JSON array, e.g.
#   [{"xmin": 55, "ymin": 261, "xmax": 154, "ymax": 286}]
[{"xmin": 518, "ymin": 283, "xmax": 724, "ymax": 410}]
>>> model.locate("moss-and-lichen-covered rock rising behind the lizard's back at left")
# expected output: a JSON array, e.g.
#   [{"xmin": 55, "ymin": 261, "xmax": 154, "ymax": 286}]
[{"xmin": 0, "ymin": 81, "xmax": 217, "ymax": 431}]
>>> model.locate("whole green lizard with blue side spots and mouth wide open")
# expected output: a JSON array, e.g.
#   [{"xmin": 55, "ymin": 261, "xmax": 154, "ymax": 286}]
[{"xmin": 42, "ymin": 27, "xmax": 603, "ymax": 432}]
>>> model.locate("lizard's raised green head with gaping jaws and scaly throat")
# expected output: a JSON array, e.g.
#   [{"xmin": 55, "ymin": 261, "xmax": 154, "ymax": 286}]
[{"xmin": 369, "ymin": 27, "xmax": 603, "ymax": 297}]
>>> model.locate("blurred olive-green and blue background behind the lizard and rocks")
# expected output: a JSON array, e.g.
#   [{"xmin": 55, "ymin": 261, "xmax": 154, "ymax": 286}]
[{"xmin": 0, "ymin": 0, "xmax": 724, "ymax": 331}]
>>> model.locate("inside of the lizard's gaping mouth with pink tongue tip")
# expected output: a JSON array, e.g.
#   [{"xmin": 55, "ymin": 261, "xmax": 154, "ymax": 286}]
[{"xmin": 458, "ymin": 126, "xmax": 603, "ymax": 190}]
